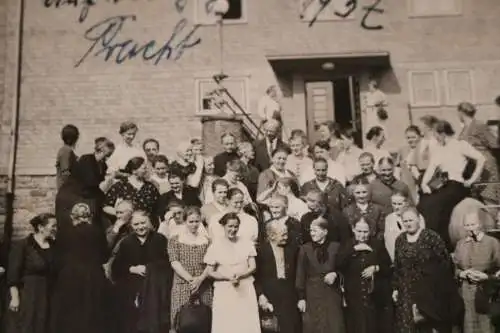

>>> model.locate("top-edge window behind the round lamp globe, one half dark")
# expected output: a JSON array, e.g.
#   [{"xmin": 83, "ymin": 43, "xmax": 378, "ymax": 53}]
[{"xmin": 194, "ymin": 0, "xmax": 247, "ymax": 25}]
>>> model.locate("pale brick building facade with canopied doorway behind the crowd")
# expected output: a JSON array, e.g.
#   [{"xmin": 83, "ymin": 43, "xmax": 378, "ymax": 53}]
[{"xmin": 0, "ymin": 0, "xmax": 500, "ymax": 235}]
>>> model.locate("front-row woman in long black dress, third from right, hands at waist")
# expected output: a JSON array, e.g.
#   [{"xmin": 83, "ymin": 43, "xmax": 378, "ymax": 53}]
[{"xmin": 337, "ymin": 219, "xmax": 391, "ymax": 333}]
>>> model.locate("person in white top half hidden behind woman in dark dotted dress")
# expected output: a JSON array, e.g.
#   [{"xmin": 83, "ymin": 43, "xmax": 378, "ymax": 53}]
[{"xmin": 384, "ymin": 192, "xmax": 425, "ymax": 261}]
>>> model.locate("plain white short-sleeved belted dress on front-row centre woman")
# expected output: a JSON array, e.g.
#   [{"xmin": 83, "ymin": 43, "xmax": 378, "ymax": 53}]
[{"xmin": 205, "ymin": 238, "xmax": 261, "ymax": 333}]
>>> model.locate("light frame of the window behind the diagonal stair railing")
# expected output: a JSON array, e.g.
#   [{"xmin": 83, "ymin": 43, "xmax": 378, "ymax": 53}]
[{"xmin": 194, "ymin": 75, "xmax": 252, "ymax": 117}]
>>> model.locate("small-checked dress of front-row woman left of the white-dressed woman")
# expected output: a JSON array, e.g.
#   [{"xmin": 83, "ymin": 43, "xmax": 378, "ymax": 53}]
[{"xmin": 168, "ymin": 237, "xmax": 212, "ymax": 323}]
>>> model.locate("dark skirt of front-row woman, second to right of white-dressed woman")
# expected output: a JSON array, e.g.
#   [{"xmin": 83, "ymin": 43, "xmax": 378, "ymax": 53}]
[{"xmin": 303, "ymin": 278, "xmax": 346, "ymax": 333}]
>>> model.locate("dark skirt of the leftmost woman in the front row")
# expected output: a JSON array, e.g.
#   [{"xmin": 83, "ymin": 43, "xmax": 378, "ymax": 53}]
[{"xmin": 5, "ymin": 275, "xmax": 49, "ymax": 333}]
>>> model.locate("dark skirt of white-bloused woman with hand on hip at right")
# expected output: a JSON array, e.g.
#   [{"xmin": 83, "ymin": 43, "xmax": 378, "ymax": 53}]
[{"xmin": 418, "ymin": 181, "xmax": 470, "ymax": 251}]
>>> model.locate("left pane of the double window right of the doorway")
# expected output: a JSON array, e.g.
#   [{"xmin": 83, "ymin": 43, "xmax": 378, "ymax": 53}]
[{"xmin": 409, "ymin": 71, "xmax": 440, "ymax": 106}]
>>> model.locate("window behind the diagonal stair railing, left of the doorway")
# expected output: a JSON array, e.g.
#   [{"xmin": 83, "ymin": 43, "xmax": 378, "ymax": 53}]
[{"xmin": 195, "ymin": 76, "xmax": 250, "ymax": 115}]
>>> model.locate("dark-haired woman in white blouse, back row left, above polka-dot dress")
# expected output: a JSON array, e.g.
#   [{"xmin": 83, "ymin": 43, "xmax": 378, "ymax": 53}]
[{"xmin": 108, "ymin": 121, "xmax": 146, "ymax": 174}]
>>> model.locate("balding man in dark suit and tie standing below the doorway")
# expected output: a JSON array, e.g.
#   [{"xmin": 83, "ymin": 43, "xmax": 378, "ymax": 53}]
[{"xmin": 255, "ymin": 119, "xmax": 288, "ymax": 172}]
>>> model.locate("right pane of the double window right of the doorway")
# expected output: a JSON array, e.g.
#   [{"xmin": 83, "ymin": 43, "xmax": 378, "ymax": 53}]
[{"xmin": 444, "ymin": 69, "xmax": 475, "ymax": 105}]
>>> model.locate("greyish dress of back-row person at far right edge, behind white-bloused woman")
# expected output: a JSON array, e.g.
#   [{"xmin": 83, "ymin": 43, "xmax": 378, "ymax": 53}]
[{"xmin": 459, "ymin": 120, "xmax": 500, "ymax": 203}]
